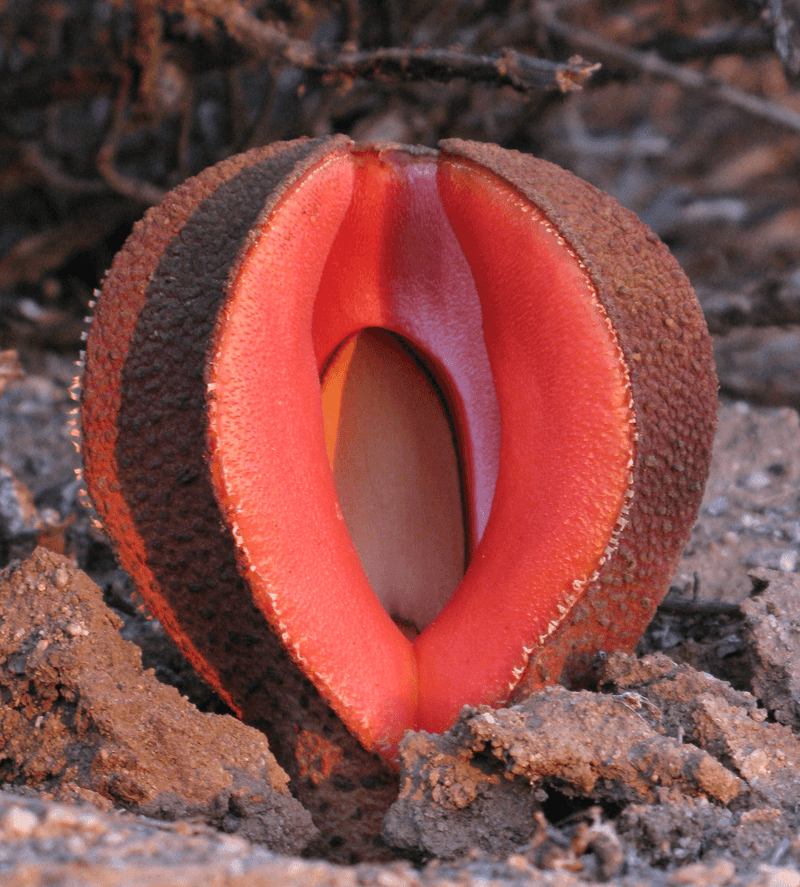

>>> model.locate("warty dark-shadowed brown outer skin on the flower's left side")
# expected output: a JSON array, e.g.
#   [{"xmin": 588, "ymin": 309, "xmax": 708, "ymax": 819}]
[{"xmin": 82, "ymin": 137, "xmax": 396, "ymax": 862}]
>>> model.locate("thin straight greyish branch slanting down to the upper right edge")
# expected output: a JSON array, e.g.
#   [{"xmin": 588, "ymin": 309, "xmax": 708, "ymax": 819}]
[{"xmin": 533, "ymin": 2, "xmax": 800, "ymax": 132}]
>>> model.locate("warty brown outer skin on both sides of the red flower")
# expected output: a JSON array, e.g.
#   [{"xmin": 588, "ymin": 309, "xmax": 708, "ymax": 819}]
[{"xmin": 82, "ymin": 137, "xmax": 716, "ymax": 857}]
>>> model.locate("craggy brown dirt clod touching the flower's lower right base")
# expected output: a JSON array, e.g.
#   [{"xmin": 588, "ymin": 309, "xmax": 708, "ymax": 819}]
[{"xmin": 384, "ymin": 687, "xmax": 744, "ymax": 857}]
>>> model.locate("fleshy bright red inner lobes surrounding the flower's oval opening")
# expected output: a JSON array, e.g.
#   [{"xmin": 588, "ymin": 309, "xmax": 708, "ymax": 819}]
[{"xmin": 209, "ymin": 151, "xmax": 634, "ymax": 757}]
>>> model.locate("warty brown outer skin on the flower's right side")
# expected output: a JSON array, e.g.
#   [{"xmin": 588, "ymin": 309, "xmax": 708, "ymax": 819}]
[{"xmin": 439, "ymin": 139, "xmax": 717, "ymax": 699}]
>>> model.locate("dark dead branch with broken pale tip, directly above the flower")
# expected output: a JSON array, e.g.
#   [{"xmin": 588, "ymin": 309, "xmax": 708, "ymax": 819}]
[{"xmin": 175, "ymin": 0, "xmax": 600, "ymax": 92}]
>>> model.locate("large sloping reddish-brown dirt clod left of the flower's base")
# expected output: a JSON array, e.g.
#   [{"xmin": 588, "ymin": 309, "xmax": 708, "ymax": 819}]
[{"xmin": 0, "ymin": 549, "xmax": 316, "ymax": 853}]
